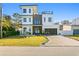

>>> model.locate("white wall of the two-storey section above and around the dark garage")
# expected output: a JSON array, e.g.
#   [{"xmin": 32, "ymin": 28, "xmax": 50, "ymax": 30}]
[{"xmin": 42, "ymin": 14, "xmax": 59, "ymax": 34}]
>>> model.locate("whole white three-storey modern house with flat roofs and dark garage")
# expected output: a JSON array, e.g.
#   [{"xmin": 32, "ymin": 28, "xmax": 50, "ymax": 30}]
[{"xmin": 20, "ymin": 5, "xmax": 59, "ymax": 35}]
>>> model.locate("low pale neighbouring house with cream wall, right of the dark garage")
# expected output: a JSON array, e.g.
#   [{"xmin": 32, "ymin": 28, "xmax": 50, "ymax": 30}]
[{"xmin": 59, "ymin": 20, "xmax": 73, "ymax": 35}]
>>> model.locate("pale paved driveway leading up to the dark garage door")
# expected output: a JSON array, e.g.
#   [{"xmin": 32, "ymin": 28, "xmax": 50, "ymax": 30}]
[{"xmin": 45, "ymin": 36, "xmax": 79, "ymax": 46}]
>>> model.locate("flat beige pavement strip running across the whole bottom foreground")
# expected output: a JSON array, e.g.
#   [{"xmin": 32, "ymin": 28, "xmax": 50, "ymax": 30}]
[{"xmin": 0, "ymin": 46, "xmax": 79, "ymax": 56}]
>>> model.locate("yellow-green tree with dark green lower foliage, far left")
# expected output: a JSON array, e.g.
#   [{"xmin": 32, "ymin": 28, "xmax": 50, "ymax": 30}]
[{"xmin": 2, "ymin": 15, "xmax": 18, "ymax": 37}]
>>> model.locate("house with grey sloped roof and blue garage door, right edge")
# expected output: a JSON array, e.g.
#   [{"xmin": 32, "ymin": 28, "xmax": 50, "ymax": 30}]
[{"xmin": 72, "ymin": 18, "xmax": 79, "ymax": 35}]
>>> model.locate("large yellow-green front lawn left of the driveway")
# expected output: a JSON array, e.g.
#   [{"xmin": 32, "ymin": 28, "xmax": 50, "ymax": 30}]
[{"xmin": 0, "ymin": 36, "xmax": 48, "ymax": 46}]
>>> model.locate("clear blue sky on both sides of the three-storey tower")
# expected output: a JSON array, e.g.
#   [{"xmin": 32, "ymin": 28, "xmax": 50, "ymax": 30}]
[{"xmin": 3, "ymin": 3, "xmax": 79, "ymax": 21}]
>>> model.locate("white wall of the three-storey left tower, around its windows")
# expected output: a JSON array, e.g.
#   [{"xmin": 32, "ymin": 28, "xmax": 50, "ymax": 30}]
[{"xmin": 20, "ymin": 6, "xmax": 37, "ymax": 34}]
